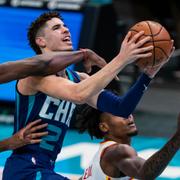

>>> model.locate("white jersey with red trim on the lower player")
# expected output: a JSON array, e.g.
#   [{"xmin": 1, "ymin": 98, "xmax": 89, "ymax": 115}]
[{"xmin": 82, "ymin": 141, "xmax": 133, "ymax": 180}]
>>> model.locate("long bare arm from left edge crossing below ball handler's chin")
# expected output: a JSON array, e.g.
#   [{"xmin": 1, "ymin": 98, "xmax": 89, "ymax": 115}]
[{"xmin": 0, "ymin": 49, "xmax": 106, "ymax": 83}]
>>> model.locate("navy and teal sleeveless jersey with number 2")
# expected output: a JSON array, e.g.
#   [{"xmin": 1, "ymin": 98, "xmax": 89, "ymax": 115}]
[{"xmin": 14, "ymin": 69, "xmax": 79, "ymax": 161}]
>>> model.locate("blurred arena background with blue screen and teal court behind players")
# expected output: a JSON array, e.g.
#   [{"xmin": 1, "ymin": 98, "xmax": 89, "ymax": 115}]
[{"xmin": 0, "ymin": 0, "xmax": 180, "ymax": 180}]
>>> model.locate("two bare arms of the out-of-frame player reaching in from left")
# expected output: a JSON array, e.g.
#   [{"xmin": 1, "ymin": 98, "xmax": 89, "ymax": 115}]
[{"xmin": 0, "ymin": 49, "xmax": 106, "ymax": 152}]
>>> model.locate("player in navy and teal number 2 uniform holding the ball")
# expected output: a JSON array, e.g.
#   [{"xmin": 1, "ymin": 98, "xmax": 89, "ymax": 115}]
[{"xmin": 3, "ymin": 12, "xmax": 165, "ymax": 180}]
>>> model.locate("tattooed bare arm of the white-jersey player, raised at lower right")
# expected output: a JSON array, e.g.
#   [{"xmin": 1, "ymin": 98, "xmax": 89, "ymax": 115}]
[{"xmin": 106, "ymin": 116, "xmax": 180, "ymax": 180}]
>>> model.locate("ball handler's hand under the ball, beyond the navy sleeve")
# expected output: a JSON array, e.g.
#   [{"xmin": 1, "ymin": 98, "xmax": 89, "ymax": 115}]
[{"xmin": 144, "ymin": 44, "xmax": 175, "ymax": 78}]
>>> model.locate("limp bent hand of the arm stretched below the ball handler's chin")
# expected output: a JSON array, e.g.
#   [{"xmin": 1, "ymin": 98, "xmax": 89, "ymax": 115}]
[{"xmin": 81, "ymin": 49, "xmax": 107, "ymax": 73}]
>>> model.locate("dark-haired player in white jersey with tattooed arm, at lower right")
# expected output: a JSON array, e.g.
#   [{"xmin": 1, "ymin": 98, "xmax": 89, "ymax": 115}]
[{"xmin": 76, "ymin": 106, "xmax": 180, "ymax": 180}]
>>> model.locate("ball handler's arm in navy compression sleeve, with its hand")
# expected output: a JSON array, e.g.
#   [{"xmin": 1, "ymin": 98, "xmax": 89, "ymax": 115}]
[{"xmin": 88, "ymin": 48, "xmax": 174, "ymax": 118}]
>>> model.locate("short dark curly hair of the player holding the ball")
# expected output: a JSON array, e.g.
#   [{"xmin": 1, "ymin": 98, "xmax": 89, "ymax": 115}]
[{"xmin": 27, "ymin": 11, "xmax": 63, "ymax": 54}]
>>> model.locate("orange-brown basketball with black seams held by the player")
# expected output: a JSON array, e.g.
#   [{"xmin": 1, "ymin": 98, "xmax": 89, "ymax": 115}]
[{"xmin": 130, "ymin": 21, "xmax": 173, "ymax": 69}]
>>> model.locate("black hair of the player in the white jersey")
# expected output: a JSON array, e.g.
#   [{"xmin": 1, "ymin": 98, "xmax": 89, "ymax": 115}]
[{"xmin": 75, "ymin": 80, "xmax": 122, "ymax": 139}]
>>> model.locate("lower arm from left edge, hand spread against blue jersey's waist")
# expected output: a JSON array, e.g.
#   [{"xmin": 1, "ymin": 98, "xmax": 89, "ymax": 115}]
[{"xmin": 0, "ymin": 120, "xmax": 48, "ymax": 152}]
